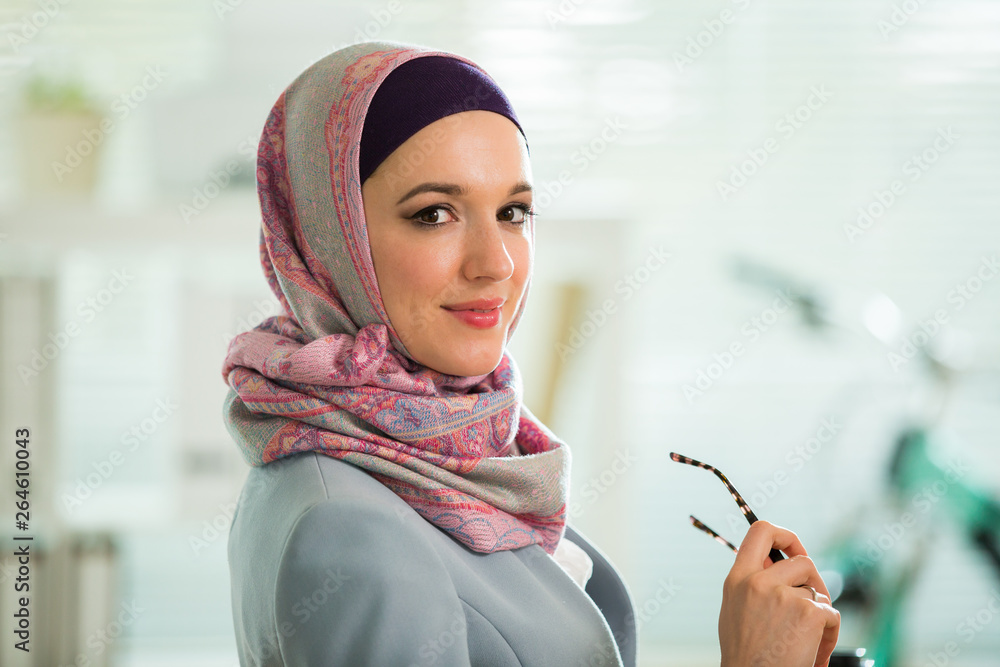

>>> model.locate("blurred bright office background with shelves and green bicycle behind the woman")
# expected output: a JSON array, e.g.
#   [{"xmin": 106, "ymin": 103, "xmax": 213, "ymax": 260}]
[{"xmin": 0, "ymin": 0, "xmax": 1000, "ymax": 667}]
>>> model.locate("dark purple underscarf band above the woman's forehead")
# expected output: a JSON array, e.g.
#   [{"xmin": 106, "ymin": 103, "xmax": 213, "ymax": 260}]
[{"xmin": 358, "ymin": 56, "xmax": 524, "ymax": 183}]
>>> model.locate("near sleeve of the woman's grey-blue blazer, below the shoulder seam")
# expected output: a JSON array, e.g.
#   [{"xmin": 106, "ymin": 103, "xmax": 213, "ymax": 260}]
[{"xmin": 273, "ymin": 480, "xmax": 469, "ymax": 667}]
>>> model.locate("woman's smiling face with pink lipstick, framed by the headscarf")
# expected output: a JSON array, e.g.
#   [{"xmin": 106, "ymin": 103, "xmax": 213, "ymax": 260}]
[{"xmin": 361, "ymin": 111, "xmax": 533, "ymax": 375}]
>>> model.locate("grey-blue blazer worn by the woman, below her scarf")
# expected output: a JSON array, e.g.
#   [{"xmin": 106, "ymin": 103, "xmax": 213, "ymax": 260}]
[{"xmin": 229, "ymin": 453, "xmax": 636, "ymax": 667}]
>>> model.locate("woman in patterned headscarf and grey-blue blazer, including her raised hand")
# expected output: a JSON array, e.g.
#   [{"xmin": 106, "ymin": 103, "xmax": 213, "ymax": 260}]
[{"xmin": 223, "ymin": 42, "xmax": 839, "ymax": 666}]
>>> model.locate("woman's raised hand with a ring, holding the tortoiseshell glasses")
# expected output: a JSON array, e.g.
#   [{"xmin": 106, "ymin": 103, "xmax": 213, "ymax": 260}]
[{"xmin": 719, "ymin": 521, "xmax": 840, "ymax": 667}]
